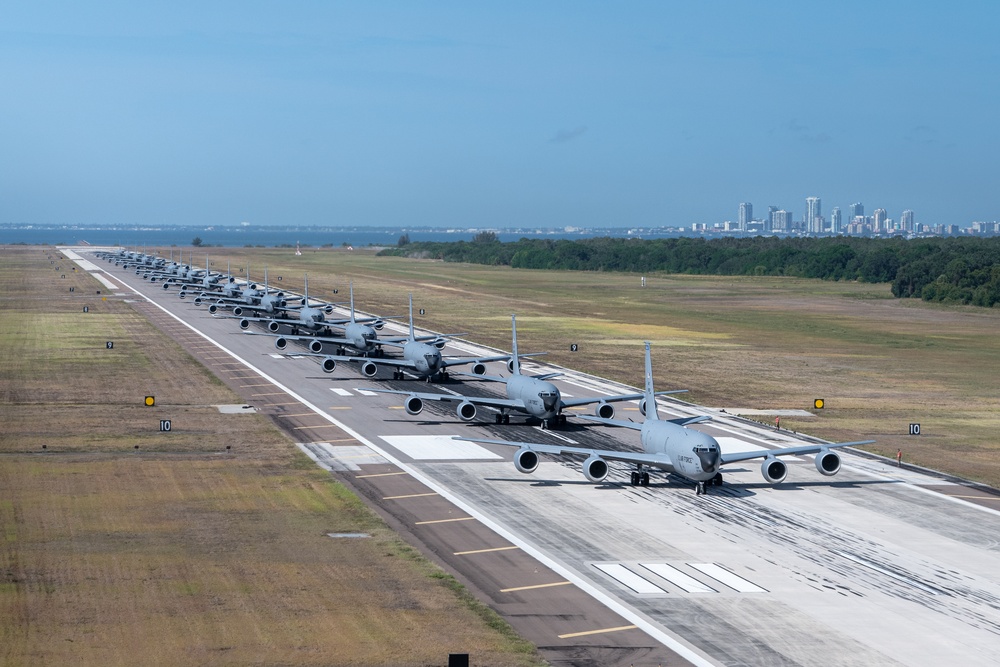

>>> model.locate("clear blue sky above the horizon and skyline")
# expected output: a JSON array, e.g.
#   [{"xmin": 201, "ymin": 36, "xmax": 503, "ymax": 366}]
[{"xmin": 0, "ymin": 0, "xmax": 1000, "ymax": 227}]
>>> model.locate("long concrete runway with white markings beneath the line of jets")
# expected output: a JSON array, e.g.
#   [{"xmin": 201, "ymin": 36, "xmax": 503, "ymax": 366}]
[{"xmin": 71, "ymin": 249, "xmax": 1000, "ymax": 665}]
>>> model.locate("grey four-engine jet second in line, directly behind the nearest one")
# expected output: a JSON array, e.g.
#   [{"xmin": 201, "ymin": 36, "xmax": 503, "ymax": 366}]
[{"xmin": 358, "ymin": 315, "xmax": 686, "ymax": 429}]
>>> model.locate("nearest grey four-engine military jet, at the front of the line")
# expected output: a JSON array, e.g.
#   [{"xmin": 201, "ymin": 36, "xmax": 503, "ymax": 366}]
[{"xmin": 458, "ymin": 342, "xmax": 875, "ymax": 495}]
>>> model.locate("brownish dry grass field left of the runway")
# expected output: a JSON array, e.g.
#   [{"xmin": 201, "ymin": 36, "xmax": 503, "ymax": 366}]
[{"xmin": 0, "ymin": 247, "xmax": 540, "ymax": 666}]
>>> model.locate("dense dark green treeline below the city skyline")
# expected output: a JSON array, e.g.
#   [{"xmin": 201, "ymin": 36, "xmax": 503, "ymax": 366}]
[{"xmin": 380, "ymin": 235, "xmax": 1000, "ymax": 307}]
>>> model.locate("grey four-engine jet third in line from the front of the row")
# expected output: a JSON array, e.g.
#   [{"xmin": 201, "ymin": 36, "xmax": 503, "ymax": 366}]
[{"xmin": 304, "ymin": 294, "xmax": 508, "ymax": 380}]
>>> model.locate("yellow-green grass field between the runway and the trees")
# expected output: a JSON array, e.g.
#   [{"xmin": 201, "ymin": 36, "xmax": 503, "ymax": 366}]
[{"xmin": 172, "ymin": 248, "xmax": 1000, "ymax": 486}]
